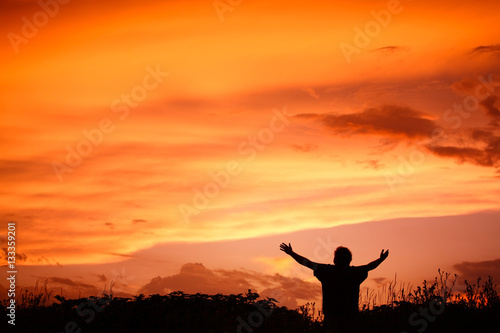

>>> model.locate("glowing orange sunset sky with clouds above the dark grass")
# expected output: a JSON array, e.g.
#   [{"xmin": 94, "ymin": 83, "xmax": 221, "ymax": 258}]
[{"xmin": 0, "ymin": 0, "xmax": 500, "ymax": 307}]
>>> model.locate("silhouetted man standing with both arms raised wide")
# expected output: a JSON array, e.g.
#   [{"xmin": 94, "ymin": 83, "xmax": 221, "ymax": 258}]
[{"xmin": 280, "ymin": 243, "xmax": 389, "ymax": 332}]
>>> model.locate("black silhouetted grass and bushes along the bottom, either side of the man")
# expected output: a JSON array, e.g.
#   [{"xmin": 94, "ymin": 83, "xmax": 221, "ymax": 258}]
[{"xmin": 0, "ymin": 271, "xmax": 500, "ymax": 333}]
